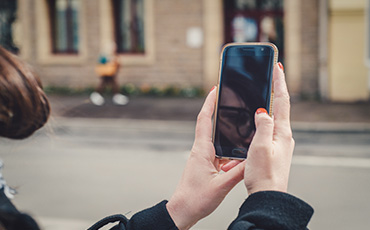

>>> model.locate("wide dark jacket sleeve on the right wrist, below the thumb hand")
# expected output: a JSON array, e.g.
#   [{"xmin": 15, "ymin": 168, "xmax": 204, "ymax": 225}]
[{"xmin": 228, "ymin": 191, "xmax": 313, "ymax": 230}]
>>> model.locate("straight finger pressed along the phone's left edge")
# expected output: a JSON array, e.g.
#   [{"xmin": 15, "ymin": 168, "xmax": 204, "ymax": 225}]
[{"xmin": 195, "ymin": 87, "xmax": 216, "ymax": 141}]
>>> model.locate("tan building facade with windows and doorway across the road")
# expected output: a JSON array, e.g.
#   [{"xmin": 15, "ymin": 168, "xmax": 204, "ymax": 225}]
[{"xmin": 3, "ymin": 0, "xmax": 370, "ymax": 101}]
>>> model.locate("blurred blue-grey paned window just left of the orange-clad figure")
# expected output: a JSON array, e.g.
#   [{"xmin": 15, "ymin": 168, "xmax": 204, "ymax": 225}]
[{"xmin": 49, "ymin": 0, "xmax": 80, "ymax": 54}]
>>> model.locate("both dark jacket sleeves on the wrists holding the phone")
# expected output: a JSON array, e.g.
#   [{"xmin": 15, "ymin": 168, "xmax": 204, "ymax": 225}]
[{"xmin": 126, "ymin": 191, "xmax": 313, "ymax": 230}]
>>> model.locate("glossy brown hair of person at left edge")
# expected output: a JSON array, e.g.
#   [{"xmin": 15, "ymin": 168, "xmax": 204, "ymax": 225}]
[{"xmin": 0, "ymin": 47, "xmax": 50, "ymax": 139}]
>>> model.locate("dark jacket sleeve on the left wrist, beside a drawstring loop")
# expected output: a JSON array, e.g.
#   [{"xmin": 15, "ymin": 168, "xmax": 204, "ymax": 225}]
[{"xmin": 126, "ymin": 201, "xmax": 178, "ymax": 230}]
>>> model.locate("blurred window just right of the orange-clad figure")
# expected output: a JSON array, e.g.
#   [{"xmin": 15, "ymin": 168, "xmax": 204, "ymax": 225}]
[{"xmin": 112, "ymin": 0, "xmax": 146, "ymax": 54}]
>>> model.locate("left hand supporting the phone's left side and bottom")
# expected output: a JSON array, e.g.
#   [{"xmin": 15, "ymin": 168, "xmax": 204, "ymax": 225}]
[{"xmin": 167, "ymin": 86, "xmax": 244, "ymax": 230}]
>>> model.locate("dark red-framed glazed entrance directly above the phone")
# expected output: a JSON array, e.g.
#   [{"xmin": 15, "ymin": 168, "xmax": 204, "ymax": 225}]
[{"xmin": 224, "ymin": 0, "xmax": 284, "ymax": 58}]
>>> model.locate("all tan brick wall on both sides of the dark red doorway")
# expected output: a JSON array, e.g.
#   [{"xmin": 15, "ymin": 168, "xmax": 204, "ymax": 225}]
[{"xmin": 21, "ymin": 0, "xmax": 319, "ymax": 98}]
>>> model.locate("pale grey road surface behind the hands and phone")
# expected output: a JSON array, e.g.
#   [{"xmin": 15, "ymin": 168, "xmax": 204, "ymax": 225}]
[{"xmin": 0, "ymin": 118, "xmax": 370, "ymax": 230}]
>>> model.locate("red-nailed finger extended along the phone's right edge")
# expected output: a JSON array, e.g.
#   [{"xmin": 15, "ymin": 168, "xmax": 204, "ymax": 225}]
[{"xmin": 273, "ymin": 63, "xmax": 290, "ymax": 129}]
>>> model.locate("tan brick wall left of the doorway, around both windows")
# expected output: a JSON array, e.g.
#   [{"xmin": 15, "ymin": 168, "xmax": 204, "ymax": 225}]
[{"xmin": 29, "ymin": 0, "xmax": 203, "ymax": 88}]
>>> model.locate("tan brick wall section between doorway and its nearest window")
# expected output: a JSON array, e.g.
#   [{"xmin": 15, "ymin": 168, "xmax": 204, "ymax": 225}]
[{"xmin": 120, "ymin": 0, "xmax": 202, "ymax": 85}]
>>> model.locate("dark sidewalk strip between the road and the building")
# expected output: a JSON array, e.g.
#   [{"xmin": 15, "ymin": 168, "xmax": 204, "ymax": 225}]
[{"xmin": 48, "ymin": 95, "xmax": 370, "ymax": 132}]
